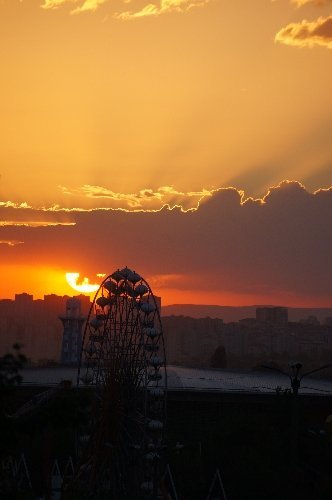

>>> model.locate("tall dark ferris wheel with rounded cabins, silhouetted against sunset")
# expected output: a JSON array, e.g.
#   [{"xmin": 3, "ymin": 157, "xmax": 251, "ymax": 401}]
[{"xmin": 71, "ymin": 267, "xmax": 167, "ymax": 500}]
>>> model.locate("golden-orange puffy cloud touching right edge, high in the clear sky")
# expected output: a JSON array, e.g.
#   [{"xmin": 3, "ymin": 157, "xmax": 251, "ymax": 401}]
[{"xmin": 275, "ymin": 16, "xmax": 332, "ymax": 49}]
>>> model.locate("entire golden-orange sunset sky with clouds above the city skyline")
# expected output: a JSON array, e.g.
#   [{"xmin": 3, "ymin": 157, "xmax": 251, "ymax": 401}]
[{"xmin": 0, "ymin": 0, "xmax": 332, "ymax": 307}]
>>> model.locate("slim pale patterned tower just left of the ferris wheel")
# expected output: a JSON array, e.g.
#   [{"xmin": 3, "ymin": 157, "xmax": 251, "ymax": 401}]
[{"xmin": 59, "ymin": 298, "xmax": 86, "ymax": 365}]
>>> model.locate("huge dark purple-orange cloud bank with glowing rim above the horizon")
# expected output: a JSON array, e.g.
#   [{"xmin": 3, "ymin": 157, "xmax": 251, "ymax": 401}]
[{"xmin": 0, "ymin": 181, "xmax": 332, "ymax": 305}]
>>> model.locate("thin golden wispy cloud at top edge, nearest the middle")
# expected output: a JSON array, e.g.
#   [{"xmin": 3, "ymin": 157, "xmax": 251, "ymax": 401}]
[{"xmin": 114, "ymin": 0, "xmax": 209, "ymax": 20}]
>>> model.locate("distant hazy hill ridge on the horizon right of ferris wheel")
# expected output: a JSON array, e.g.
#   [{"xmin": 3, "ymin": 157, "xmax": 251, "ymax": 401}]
[{"xmin": 161, "ymin": 304, "xmax": 332, "ymax": 323}]
